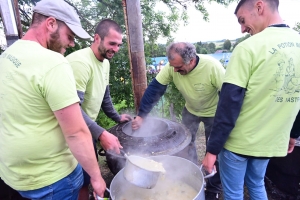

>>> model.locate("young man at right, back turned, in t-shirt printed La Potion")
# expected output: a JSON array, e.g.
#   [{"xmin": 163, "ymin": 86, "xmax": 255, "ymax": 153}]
[{"xmin": 203, "ymin": 0, "xmax": 300, "ymax": 199}]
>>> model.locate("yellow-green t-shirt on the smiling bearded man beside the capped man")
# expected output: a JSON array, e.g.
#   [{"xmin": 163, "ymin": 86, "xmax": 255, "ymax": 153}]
[{"xmin": 67, "ymin": 47, "xmax": 110, "ymax": 120}]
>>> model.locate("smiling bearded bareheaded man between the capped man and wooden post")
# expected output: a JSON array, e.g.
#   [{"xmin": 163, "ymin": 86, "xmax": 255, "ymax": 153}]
[{"xmin": 67, "ymin": 19, "xmax": 131, "ymax": 200}]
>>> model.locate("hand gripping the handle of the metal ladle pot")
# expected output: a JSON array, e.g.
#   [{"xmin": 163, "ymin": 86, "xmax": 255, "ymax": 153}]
[{"xmin": 99, "ymin": 131, "xmax": 123, "ymax": 154}]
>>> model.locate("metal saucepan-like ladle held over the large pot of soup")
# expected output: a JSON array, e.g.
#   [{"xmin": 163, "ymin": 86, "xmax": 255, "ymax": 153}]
[{"xmin": 121, "ymin": 150, "xmax": 164, "ymax": 189}]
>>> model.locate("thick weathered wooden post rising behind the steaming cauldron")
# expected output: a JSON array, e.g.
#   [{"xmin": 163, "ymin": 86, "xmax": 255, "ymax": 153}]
[{"xmin": 122, "ymin": 0, "xmax": 147, "ymax": 113}]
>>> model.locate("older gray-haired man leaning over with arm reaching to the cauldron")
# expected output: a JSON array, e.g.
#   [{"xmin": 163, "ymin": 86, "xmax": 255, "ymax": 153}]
[{"xmin": 132, "ymin": 42, "xmax": 225, "ymax": 199}]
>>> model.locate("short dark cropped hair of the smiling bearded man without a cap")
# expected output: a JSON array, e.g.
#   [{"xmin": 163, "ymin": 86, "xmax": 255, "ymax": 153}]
[{"xmin": 95, "ymin": 19, "xmax": 122, "ymax": 40}]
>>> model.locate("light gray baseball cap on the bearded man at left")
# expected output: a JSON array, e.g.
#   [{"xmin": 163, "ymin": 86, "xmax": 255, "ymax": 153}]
[{"xmin": 32, "ymin": 0, "xmax": 90, "ymax": 39}]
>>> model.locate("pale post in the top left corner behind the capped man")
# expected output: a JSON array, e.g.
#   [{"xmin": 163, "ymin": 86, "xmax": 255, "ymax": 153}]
[{"xmin": 0, "ymin": 0, "xmax": 22, "ymax": 47}]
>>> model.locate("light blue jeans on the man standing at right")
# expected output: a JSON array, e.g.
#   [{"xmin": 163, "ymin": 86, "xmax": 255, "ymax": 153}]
[{"xmin": 218, "ymin": 149, "xmax": 269, "ymax": 200}]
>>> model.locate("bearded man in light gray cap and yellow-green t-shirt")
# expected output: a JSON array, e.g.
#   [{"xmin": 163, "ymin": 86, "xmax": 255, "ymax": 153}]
[{"xmin": 0, "ymin": 0, "xmax": 106, "ymax": 199}]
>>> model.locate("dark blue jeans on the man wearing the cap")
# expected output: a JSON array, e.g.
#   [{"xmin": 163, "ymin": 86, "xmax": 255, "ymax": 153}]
[{"xmin": 18, "ymin": 164, "xmax": 83, "ymax": 200}]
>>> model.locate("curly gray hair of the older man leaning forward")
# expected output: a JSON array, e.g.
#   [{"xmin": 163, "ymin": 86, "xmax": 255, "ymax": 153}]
[{"xmin": 167, "ymin": 42, "xmax": 197, "ymax": 64}]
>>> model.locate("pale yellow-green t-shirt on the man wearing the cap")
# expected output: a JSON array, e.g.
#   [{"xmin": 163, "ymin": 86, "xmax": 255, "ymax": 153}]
[{"xmin": 0, "ymin": 40, "xmax": 79, "ymax": 191}]
